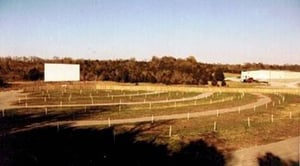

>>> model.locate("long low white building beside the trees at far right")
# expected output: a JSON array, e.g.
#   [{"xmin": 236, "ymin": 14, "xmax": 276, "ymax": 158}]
[{"xmin": 241, "ymin": 70, "xmax": 300, "ymax": 81}]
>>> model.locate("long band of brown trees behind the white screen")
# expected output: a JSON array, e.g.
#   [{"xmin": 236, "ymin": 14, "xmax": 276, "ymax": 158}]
[{"xmin": 0, "ymin": 56, "xmax": 300, "ymax": 85}]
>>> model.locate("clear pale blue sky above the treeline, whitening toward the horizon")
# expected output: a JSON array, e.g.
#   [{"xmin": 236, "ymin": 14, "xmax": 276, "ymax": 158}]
[{"xmin": 0, "ymin": 0, "xmax": 300, "ymax": 64}]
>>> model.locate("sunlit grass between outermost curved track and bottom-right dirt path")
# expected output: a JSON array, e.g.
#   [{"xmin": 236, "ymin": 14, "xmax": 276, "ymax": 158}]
[{"xmin": 110, "ymin": 95, "xmax": 300, "ymax": 151}]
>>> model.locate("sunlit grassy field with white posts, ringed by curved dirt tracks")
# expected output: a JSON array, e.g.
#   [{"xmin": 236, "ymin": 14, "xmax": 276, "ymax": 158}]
[{"xmin": 0, "ymin": 83, "xmax": 300, "ymax": 154}]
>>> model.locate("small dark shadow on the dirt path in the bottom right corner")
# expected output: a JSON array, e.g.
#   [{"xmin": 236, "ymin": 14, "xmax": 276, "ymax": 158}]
[{"xmin": 257, "ymin": 152, "xmax": 299, "ymax": 166}]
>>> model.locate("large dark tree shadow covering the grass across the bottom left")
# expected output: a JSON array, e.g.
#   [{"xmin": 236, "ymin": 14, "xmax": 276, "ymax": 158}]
[{"xmin": 0, "ymin": 124, "xmax": 225, "ymax": 166}]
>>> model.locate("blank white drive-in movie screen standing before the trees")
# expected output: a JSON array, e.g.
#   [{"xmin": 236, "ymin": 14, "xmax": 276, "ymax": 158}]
[{"xmin": 44, "ymin": 63, "xmax": 80, "ymax": 82}]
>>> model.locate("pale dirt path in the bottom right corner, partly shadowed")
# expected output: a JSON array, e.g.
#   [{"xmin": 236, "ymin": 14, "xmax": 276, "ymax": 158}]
[{"xmin": 227, "ymin": 136, "xmax": 300, "ymax": 166}]
